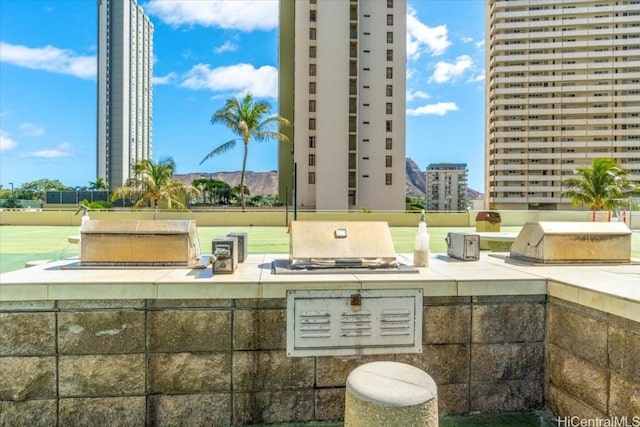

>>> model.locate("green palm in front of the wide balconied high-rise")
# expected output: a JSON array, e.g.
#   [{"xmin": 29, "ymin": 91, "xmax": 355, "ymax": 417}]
[{"xmin": 562, "ymin": 158, "xmax": 636, "ymax": 221}]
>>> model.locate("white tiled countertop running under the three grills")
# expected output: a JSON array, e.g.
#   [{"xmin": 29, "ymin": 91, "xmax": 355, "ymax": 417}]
[{"xmin": 0, "ymin": 252, "xmax": 640, "ymax": 321}]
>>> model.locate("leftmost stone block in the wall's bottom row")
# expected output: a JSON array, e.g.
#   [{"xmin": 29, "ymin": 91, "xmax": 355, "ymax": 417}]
[{"xmin": 0, "ymin": 399, "xmax": 58, "ymax": 427}]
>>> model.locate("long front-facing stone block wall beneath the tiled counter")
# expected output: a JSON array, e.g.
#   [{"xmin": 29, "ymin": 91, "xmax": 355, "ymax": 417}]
[{"xmin": 0, "ymin": 295, "xmax": 544, "ymax": 426}]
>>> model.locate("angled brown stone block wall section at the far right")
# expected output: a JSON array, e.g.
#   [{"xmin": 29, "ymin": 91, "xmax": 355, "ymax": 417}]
[{"xmin": 547, "ymin": 298, "xmax": 640, "ymax": 425}]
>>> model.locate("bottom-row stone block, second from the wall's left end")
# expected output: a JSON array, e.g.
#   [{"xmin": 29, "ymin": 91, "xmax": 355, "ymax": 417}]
[{"xmin": 59, "ymin": 396, "xmax": 147, "ymax": 427}]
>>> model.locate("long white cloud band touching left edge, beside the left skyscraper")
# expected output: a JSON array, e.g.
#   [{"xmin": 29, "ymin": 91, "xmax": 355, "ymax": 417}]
[{"xmin": 0, "ymin": 42, "xmax": 97, "ymax": 80}]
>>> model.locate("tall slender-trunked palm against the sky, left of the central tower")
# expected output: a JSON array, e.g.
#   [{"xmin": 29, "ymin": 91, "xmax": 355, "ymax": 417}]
[{"xmin": 200, "ymin": 93, "xmax": 289, "ymax": 210}]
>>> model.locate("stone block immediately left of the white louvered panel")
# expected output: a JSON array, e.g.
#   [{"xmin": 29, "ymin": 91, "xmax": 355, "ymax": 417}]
[{"xmin": 233, "ymin": 309, "xmax": 287, "ymax": 350}]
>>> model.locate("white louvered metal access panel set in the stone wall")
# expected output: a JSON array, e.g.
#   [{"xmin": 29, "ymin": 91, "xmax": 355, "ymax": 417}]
[{"xmin": 287, "ymin": 289, "xmax": 423, "ymax": 357}]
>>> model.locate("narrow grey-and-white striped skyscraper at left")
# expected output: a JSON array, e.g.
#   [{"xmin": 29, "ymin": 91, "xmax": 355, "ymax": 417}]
[{"xmin": 97, "ymin": 0, "xmax": 153, "ymax": 189}]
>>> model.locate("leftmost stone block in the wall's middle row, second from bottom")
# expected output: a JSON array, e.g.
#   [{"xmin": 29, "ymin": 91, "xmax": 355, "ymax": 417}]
[{"xmin": 0, "ymin": 356, "xmax": 56, "ymax": 401}]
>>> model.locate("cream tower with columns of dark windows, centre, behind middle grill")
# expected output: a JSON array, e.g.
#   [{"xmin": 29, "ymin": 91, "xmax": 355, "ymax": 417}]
[{"xmin": 278, "ymin": 0, "xmax": 407, "ymax": 210}]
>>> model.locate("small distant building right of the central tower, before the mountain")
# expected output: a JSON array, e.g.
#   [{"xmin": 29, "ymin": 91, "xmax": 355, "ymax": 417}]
[{"xmin": 426, "ymin": 163, "xmax": 469, "ymax": 211}]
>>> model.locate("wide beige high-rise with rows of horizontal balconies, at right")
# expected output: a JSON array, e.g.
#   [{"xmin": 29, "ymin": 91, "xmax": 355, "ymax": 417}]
[{"xmin": 485, "ymin": 0, "xmax": 640, "ymax": 209}]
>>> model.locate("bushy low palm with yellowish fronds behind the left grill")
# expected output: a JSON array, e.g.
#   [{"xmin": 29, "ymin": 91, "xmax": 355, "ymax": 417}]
[{"xmin": 111, "ymin": 158, "xmax": 200, "ymax": 209}]
